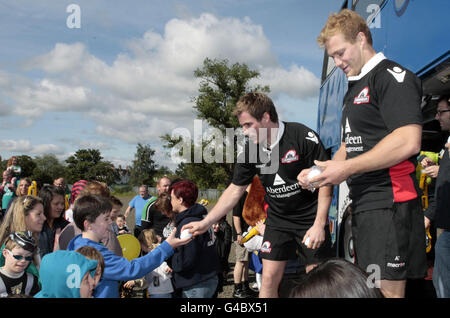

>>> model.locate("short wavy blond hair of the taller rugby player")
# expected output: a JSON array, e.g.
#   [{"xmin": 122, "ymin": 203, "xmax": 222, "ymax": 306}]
[{"xmin": 317, "ymin": 9, "xmax": 372, "ymax": 48}]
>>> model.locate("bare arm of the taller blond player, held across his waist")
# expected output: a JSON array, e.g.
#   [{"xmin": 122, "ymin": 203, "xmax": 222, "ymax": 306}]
[{"xmin": 310, "ymin": 124, "xmax": 422, "ymax": 186}]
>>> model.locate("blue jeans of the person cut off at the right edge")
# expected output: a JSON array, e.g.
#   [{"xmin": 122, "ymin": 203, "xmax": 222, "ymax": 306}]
[{"xmin": 433, "ymin": 231, "xmax": 450, "ymax": 298}]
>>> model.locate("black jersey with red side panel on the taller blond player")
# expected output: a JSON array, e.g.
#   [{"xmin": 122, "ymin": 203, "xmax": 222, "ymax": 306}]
[{"xmin": 341, "ymin": 53, "xmax": 422, "ymax": 212}]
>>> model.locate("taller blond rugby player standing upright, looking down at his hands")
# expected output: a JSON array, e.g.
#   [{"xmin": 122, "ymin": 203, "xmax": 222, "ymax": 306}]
[{"xmin": 299, "ymin": 9, "xmax": 427, "ymax": 297}]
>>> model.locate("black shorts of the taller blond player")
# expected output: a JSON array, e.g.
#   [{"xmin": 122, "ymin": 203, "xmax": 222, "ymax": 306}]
[{"xmin": 352, "ymin": 199, "xmax": 427, "ymax": 280}]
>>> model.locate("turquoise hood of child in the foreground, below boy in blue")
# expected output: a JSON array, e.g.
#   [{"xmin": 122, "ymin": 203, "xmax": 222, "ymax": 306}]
[{"xmin": 34, "ymin": 251, "xmax": 97, "ymax": 298}]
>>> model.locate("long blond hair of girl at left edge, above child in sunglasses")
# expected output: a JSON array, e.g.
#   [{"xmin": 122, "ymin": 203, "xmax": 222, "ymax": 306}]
[{"xmin": 0, "ymin": 195, "xmax": 43, "ymax": 245}]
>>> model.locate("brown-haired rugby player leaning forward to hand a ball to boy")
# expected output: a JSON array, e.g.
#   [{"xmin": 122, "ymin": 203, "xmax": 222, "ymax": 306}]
[{"xmin": 184, "ymin": 92, "xmax": 332, "ymax": 298}]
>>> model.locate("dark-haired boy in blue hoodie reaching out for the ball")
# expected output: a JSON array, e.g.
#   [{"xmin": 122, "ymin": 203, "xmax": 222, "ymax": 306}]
[{"xmin": 67, "ymin": 195, "xmax": 191, "ymax": 298}]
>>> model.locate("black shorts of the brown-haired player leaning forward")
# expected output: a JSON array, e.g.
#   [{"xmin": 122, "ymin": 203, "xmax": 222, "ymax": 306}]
[{"xmin": 259, "ymin": 225, "xmax": 335, "ymax": 265}]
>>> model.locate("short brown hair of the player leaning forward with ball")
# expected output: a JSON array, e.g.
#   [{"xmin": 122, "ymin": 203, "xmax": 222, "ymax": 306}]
[{"xmin": 233, "ymin": 92, "xmax": 278, "ymax": 123}]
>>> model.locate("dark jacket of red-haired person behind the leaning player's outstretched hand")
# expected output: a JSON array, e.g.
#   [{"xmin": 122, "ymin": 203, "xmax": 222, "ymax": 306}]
[{"xmin": 171, "ymin": 204, "xmax": 220, "ymax": 288}]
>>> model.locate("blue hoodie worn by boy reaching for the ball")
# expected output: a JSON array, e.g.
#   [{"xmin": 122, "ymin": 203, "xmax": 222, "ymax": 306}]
[{"xmin": 67, "ymin": 234, "xmax": 173, "ymax": 298}]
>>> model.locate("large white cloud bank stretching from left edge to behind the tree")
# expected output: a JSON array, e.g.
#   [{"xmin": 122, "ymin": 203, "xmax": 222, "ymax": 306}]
[{"xmin": 0, "ymin": 13, "xmax": 319, "ymax": 145}]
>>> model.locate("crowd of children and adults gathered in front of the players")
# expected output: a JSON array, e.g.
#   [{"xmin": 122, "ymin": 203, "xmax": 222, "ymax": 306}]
[{"xmin": 0, "ymin": 160, "xmax": 229, "ymax": 298}]
